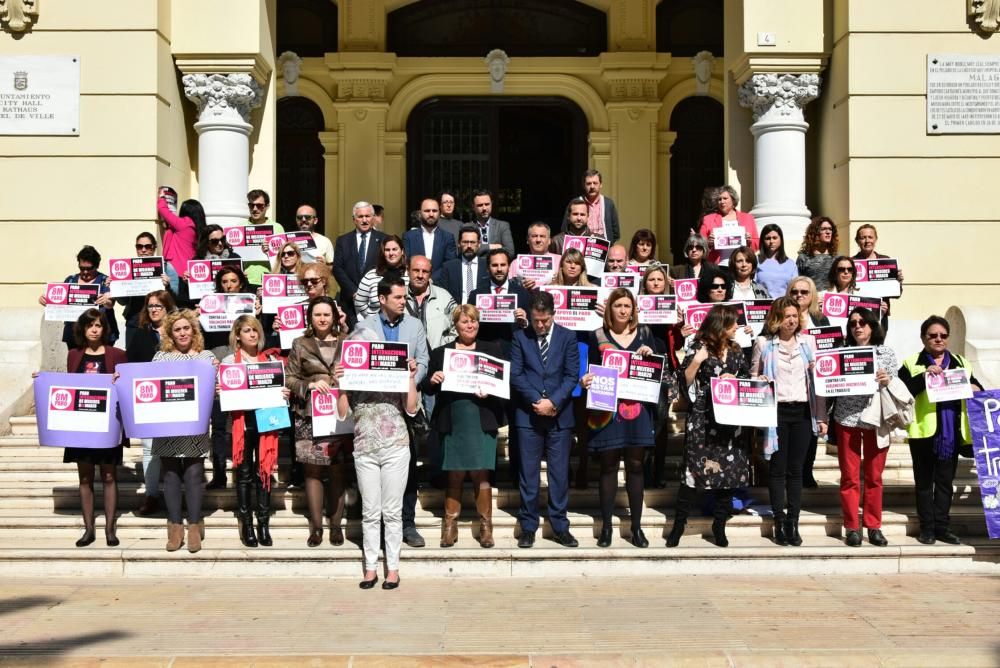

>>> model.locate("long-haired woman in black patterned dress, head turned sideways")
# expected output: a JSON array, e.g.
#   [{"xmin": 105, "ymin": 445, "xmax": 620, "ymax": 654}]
[{"xmin": 667, "ymin": 304, "xmax": 750, "ymax": 547}]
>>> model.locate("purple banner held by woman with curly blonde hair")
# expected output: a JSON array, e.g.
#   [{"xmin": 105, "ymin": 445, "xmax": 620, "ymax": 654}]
[{"xmin": 115, "ymin": 360, "xmax": 216, "ymax": 438}]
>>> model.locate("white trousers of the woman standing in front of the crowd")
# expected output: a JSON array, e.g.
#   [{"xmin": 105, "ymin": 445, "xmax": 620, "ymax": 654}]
[{"xmin": 354, "ymin": 446, "xmax": 410, "ymax": 571}]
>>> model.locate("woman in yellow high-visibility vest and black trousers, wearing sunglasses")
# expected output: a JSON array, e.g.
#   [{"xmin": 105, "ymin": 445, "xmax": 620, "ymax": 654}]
[{"xmin": 899, "ymin": 315, "xmax": 983, "ymax": 545}]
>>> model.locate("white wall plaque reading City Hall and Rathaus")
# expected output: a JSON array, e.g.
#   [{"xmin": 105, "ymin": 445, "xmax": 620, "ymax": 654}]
[{"xmin": 0, "ymin": 56, "xmax": 80, "ymax": 135}]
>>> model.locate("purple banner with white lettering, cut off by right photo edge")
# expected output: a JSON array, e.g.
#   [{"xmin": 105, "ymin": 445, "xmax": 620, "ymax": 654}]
[{"xmin": 965, "ymin": 390, "xmax": 1000, "ymax": 538}]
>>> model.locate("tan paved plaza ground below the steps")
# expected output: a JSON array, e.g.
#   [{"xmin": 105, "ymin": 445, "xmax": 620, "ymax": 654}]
[{"xmin": 0, "ymin": 572, "xmax": 1000, "ymax": 668}]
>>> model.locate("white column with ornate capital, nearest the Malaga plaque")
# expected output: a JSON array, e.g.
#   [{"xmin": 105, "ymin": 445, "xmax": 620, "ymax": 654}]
[{"xmin": 740, "ymin": 73, "xmax": 820, "ymax": 243}]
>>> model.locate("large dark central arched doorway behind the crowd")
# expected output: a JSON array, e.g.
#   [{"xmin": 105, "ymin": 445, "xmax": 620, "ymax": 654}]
[{"xmin": 406, "ymin": 97, "xmax": 587, "ymax": 251}]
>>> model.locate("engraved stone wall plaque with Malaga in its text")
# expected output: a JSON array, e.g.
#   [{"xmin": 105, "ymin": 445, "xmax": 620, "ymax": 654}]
[{"xmin": 927, "ymin": 53, "xmax": 1000, "ymax": 134}]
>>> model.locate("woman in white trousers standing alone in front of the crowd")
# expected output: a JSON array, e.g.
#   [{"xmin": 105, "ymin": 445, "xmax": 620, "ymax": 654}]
[{"xmin": 333, "ymin": 327, "xmax": 420, "ymax": 589}]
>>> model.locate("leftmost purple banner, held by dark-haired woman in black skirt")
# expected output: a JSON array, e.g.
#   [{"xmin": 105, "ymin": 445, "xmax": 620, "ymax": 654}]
[{"xmin": 35, "ymin": 371, "xmax": 122, "ymax": 448}]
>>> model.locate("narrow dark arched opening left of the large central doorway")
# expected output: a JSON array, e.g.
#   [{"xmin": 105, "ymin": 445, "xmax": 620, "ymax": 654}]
[{"xmin": 272, "ymin": 97, "xmax": 326, "ymax": 233}]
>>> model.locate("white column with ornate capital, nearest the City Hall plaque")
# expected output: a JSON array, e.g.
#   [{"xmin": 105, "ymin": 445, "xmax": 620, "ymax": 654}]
[{"xmin": 182, "ymin": 74, "xmax": 262, "ymax": 227}]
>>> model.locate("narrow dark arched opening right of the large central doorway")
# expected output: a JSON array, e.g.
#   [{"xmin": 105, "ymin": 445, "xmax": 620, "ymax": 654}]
[{"xmin": 670, "ymin": 97, "xmax": 725, "ymax": 262}]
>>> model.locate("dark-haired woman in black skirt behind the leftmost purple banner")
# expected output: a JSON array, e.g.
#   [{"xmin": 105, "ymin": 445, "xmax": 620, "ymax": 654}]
[{"xmin": 63, "ymin": 308, "xmax": 127, "ymax": 547}]
